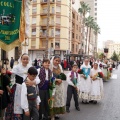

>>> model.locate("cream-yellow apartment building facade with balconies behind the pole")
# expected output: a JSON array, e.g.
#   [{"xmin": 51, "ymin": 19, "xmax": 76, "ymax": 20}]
[{"xmin": 29, "ymin": 0, "xmax": 73, "ymax": 59}]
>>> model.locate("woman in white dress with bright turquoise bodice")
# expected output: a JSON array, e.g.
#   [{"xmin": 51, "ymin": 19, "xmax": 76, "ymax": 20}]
[{"xmin": 80, "ymin": 58, "xmax": 91, "ymax": 104}]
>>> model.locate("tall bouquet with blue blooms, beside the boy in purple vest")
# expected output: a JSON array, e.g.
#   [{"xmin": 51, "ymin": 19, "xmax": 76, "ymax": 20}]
[{"xmin": 48, "ymin": 77, "xmax": 55, "ymax": 109}]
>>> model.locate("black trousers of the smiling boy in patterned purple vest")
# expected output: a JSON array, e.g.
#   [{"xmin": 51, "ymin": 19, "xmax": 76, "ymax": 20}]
[{"xmin": 39, "ymin": 90, "xmax": 49, "ymax": 119}]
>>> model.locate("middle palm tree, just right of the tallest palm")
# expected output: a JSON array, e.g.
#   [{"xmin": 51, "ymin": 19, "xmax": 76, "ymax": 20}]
[{"xmin": 85, "ymin": 16, "xmax": 94, "ymax": 53}]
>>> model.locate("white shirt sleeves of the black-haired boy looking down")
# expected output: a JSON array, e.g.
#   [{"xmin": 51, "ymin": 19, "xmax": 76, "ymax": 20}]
[{"xmin": 21, "ymin": 82, "xmax": 41, "ymax": 112}]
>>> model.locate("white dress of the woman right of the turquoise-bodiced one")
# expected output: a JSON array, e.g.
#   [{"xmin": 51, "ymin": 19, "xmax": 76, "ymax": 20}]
[{"xmin": 90, "ymin": 68, "xmax": 103, "ymax": 100}]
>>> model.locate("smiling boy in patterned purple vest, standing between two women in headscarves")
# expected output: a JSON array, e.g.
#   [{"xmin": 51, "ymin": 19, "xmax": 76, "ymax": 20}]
[{"xmin": 38, "ymin": 59, "xmax": 52, "ymax": 120}]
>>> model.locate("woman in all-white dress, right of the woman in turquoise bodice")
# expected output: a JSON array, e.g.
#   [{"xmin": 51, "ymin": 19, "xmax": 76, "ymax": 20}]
[{"xmin": 90, "ymin": 63, "xmax": 103, "ymax": 104}]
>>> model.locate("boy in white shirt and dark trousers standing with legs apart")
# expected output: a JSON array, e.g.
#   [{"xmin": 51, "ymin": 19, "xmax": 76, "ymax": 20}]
[{"xmin": 66, "ymin": 63, "xmax": 80, "ymax": 113}]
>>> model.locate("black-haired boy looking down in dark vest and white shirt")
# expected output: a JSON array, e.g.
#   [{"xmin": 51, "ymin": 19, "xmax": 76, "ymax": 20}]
[{"xmin": 21, "ymin": 67, "xmax": 40, "ymax": 120}]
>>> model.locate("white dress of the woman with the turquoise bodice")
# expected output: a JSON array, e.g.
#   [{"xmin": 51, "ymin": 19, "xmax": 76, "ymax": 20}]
[{"xmin": 79, "ymin": 64, "xmax": 91, "ymax": 100}]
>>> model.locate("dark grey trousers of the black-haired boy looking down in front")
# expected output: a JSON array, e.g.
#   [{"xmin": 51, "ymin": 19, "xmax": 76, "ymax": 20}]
[{"xmin": 23, "ymin": 100, "xmax": 39, "ymax": 120}]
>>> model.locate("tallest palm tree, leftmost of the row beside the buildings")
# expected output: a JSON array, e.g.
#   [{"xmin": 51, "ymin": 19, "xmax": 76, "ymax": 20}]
[{"xmin": 78, "ymin": 1, "xmax": 90, "ymax": 54}]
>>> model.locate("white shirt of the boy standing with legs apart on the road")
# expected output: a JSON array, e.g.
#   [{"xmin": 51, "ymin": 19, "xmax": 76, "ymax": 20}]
[{"xmin": 67, "ymin": 72, "xmax": 80, "ymax": 89}]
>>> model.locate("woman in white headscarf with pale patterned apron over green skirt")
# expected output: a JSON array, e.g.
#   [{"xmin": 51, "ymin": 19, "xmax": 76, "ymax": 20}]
[{"xmin": 50, "ymin": 56, "xmax": 65, "ymax": 119}]
